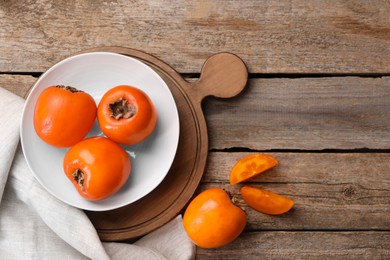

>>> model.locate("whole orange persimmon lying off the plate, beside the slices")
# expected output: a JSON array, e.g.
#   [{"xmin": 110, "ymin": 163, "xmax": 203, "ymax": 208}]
[{"xmin": 183, "ymin": 188, "xmax": 247, "ymax": 248}]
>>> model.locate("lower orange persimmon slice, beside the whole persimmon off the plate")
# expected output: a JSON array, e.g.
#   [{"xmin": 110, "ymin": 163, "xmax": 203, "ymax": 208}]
[{"xmin": 241, "ymin": 186, "xmax": 295, "ymax": 215}]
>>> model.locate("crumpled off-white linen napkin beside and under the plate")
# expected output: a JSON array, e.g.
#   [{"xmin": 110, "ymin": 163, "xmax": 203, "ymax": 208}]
[{"xmin": 0, "ymin": 88, "xmax": 195, "ymax": 260}]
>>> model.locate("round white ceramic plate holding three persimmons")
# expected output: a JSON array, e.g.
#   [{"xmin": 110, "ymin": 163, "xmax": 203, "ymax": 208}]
[{"xmin": 21, "ymin": 52, "xmax": 179, "ymax": 211}]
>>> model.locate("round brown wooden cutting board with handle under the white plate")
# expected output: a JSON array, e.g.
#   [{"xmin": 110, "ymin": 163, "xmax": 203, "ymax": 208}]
[{"xmin": 82, "ymin": 47, "xmax": 248, "ymax": 241}]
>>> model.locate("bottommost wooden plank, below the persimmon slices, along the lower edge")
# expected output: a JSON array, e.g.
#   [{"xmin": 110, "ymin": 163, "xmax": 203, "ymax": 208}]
[{"xmin": 196, "ymin": 232, "xmax": 390, "ymax": 260}]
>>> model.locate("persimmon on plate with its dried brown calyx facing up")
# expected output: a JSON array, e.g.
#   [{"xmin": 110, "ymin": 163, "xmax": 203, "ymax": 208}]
[{"xmin": 97, "ymin": 85, "xmax": 157, "ymax": 145}]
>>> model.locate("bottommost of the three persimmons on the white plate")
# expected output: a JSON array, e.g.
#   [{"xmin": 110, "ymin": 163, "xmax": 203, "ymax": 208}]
[{"xmin": 63, "ymin": 136, "xmax": 131, "ymax": 200}]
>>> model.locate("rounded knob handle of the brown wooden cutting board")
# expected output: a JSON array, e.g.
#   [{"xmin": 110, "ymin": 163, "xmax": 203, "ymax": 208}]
[{"xmin": 189, "ymin": 52, "xmax": 248, "ymax": 103}]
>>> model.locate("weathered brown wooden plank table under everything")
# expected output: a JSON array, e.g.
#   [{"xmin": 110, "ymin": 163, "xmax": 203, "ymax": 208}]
[{"xmin": 0, "ymin": 0, "xmax": 390, "ymax": 259}]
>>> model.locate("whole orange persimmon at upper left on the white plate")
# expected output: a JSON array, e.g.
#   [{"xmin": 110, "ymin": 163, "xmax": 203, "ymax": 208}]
[{"xmin": 33, "ymin": 85, "xmax": 97, "ymax": 148}]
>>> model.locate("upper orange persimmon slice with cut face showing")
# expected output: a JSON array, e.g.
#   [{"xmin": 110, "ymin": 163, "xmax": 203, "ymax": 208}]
[{"xmin": 230, "ymin": 154, "xmax": 278, "ymax": 185}]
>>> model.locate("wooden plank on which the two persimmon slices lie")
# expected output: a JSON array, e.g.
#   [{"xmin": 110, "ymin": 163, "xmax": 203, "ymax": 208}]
[{"xmin": 197, "ymin": 152, "xmax": 390, "ymax": 231}]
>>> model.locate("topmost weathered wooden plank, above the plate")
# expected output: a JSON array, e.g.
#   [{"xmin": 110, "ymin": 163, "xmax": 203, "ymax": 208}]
[{"xmin": 0, "ymin": 0, "xmax": 390, "ymax": 74}]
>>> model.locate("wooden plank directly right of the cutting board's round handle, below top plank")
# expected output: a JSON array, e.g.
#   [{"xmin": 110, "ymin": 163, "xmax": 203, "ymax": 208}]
[{"xmin": 204, "ymin": 77, "xmax": 390, "ymax": 150}]
